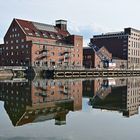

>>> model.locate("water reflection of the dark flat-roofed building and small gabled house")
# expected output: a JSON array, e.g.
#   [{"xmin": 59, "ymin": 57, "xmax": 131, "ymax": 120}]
[{"xmin": 83, "ymin": 78, "xmax": 140, "ymax": 117}]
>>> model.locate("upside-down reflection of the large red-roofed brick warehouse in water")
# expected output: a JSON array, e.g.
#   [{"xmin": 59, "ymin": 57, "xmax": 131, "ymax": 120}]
[{"xmin": 0, "ymin": 79, "xmax": 82, "ymax": 126}]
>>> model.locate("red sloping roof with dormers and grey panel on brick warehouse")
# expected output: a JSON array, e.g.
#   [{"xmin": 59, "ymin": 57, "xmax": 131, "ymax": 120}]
[{"xmin": 15, "ymin": 19, "xmax": 70, "ymax": 40}]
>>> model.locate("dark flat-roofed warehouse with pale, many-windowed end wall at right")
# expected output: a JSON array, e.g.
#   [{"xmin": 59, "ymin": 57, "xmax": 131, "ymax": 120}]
[{"xmin": 91, "ymin": 28, "xmax": 140, "ymax": 69}]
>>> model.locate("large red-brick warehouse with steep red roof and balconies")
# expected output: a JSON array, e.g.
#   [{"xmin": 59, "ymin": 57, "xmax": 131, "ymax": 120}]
[{"xmin": 0, "ymin": 19, "xmax": 83, "ymax": 67}]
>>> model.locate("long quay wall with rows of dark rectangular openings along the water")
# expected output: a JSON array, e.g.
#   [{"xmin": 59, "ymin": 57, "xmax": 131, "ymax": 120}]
[{"xmin": 43, "ymin": 69, "xmax": 140, "ymax": 78}]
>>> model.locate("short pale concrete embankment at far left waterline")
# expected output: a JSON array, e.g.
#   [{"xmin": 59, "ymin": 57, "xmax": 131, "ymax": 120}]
[{"xmin": 0, "ymin": 70, "xmax": 14, "ymax": 79}]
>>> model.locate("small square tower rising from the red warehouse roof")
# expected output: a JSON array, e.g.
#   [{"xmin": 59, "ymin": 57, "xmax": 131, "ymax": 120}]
[{"xmin": 55, "ymin": 20, "xmax": 67, "ymax": 31}]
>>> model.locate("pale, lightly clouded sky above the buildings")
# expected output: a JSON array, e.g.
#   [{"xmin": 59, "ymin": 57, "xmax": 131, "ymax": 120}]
[{"xmin": 0, "ymin": 0, "xmax": 140, "ymax": 46}]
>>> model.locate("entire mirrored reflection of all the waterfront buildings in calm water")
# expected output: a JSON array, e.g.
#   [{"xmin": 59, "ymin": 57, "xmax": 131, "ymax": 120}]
[{"xmin": 0, "ymin": 78, "xmax": 140, "ymax": 126}]
